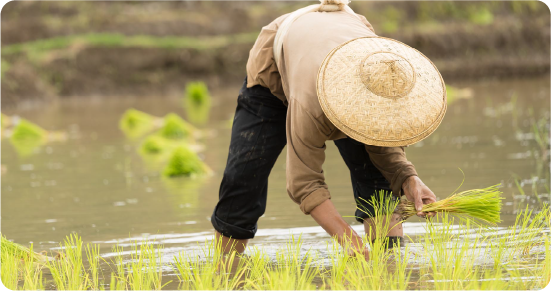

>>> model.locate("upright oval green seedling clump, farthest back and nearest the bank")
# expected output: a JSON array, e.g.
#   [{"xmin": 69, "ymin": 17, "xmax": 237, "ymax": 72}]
[{"xmin": 184, "ymin": 82, "xmax": 211, "ymax": 124}]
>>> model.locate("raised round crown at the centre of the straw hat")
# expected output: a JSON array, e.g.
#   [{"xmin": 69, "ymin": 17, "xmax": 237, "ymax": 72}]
[{"xmin": 360, "ymin": 51, "xmax": 415, "ymax": 99}]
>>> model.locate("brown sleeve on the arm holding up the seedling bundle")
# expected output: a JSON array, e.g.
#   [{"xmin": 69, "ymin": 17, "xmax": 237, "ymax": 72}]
[{"xmin": 365, "ymin": 145, "xmax": 417, "ymax": 197}]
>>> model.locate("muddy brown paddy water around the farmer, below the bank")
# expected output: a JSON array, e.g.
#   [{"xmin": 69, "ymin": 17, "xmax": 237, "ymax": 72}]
[{"xmin": 0, "ymin": 78, "xmax": 551, "ymax": 256}]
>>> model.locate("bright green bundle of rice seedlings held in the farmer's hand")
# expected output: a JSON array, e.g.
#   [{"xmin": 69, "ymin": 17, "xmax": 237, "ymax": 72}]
[{"xmin": 396, "ymin": 185, "xmax": 503, "ymax": 225}]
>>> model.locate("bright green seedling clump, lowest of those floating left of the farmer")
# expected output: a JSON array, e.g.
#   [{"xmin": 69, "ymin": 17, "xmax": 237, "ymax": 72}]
[{"xmin": 163, "ymin": 146, "xmax": 210, "ymax": 177}]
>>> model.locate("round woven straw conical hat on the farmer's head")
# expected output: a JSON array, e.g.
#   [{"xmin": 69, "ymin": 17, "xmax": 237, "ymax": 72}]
[{"xmin": 317, "ymin": 37, "xmax": 447, "ymax": 147}]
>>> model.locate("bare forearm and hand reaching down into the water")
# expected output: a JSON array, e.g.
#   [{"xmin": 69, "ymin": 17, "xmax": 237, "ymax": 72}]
[{"xmin": 310, "ymin": 200, "xmax": 369, "ymax": 259}]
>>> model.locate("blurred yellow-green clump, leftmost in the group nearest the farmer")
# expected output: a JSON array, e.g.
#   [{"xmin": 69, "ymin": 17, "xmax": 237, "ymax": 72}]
[{"xmin": 119, "ymin": 109, "xmax": 162, "ymax": 138}]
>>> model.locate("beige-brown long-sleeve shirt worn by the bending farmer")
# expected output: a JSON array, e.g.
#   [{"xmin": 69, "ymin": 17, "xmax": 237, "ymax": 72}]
[{"xmin": 247, "ymin": 11, "xmax": 417, "ymax": 214}]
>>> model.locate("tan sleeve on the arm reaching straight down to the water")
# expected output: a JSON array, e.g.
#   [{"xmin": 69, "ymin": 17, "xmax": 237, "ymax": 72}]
[{"xmin": 287, "ymin": 100, "xmax": 331, "ymax": 214}]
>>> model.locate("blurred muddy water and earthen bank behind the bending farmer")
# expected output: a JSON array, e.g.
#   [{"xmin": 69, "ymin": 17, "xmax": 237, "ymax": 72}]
[{"xmin": 0, "ymin": 0, "xmax": 551, "ymax": 256}]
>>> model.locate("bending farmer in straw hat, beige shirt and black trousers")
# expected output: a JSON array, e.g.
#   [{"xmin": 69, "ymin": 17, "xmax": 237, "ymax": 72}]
[{"xmin": 211, "ymin": 0, "xmax": 446, "ymax": 257}]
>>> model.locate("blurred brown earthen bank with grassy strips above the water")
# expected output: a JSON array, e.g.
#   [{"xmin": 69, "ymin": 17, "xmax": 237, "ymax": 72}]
[{"xmin": 0, "ymin": 0, "xmax": 551, "ymax": 107}]
